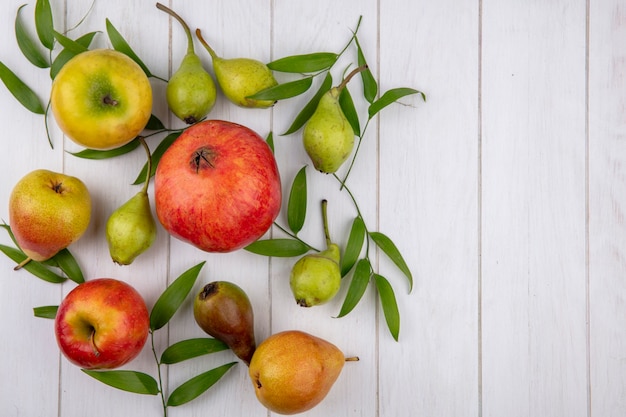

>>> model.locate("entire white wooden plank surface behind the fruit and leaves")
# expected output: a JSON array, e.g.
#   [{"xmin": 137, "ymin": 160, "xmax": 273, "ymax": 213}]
[{"xmin": 0, "ymin": 0, "xmax": 626, "ymax": 417}]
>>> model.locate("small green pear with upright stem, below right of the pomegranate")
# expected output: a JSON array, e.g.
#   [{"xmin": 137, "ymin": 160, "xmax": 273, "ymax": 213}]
[{"xmin": 289, "ymin": 200, "xmax": 341, "ymax": 307}]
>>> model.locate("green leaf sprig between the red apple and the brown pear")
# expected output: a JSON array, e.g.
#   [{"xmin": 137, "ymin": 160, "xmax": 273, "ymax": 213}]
[{"xmin": 82, "ymin": 262, "xmax": 237, "ymax": 417}]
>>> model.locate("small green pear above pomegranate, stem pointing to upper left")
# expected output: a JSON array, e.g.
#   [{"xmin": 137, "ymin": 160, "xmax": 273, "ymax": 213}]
[{"xmin": 196, "ymin": 29, "xmax": 278, "ymax": 108}]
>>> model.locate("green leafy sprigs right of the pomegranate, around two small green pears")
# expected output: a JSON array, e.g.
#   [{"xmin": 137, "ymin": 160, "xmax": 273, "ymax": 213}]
[{"xmin": 245, "ymin": 18, "xmax": 426, "ymax": 340}]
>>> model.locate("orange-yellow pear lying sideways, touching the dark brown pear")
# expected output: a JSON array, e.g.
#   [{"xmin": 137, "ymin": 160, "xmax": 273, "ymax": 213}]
[{"xmin": 248, "ymin": 330, "xmax": 358, "ymax": 414}]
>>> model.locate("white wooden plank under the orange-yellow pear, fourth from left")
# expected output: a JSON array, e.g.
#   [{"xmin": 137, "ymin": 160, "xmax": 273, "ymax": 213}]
[{"xmin": 271, "ymin": 0, "xmax": 377, "ymax": 416}]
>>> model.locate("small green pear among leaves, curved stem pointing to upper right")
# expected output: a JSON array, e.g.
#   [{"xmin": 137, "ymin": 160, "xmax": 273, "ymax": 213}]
[{"xmin": 302, "ymin": 66, "xmax": 367, "ymax": 174}]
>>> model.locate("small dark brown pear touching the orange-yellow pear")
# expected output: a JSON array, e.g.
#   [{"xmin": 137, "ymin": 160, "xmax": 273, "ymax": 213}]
[{"xmin": 193, "ymin": 281, "xmax": 256, "ymax": 365}]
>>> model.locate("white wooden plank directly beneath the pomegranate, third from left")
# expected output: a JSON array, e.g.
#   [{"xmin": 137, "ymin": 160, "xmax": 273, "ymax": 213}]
[{"xmin": 159, "ymin": 1, "xmax": 271, "ymax": 416}]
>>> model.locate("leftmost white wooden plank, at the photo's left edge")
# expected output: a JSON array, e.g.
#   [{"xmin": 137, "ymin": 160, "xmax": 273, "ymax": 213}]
[{"xmin": 0, "ymin": 1, "xmax": 63, "ymax": 416}]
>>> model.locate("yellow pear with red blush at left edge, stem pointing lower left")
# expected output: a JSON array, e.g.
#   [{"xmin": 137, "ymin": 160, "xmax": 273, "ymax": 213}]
[{"xmin": 9, "ymin": 169, "xmax": 91, "ymax": 269}]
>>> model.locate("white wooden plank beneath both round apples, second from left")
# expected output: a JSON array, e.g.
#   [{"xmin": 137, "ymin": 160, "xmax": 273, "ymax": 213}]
[{"xmin": 54, "ymin": 1, "xmax": 168, "ymax": 416}]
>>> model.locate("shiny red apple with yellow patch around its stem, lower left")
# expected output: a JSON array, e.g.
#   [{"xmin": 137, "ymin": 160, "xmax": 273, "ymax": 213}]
[{"xmin": 54, "ymin": 278, "xmax": 150, "ymax": 369}]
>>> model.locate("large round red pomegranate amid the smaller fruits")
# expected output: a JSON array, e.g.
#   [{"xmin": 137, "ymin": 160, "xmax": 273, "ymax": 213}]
[{"xmin": 154, "ymin": 120, "xmax": 281, "ymax": 252}]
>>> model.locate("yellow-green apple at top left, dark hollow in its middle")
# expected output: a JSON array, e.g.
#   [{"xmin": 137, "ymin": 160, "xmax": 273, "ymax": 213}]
[{"xmin": 50, "ymin": 49, "xmax": 152, "ymax": 150}]
